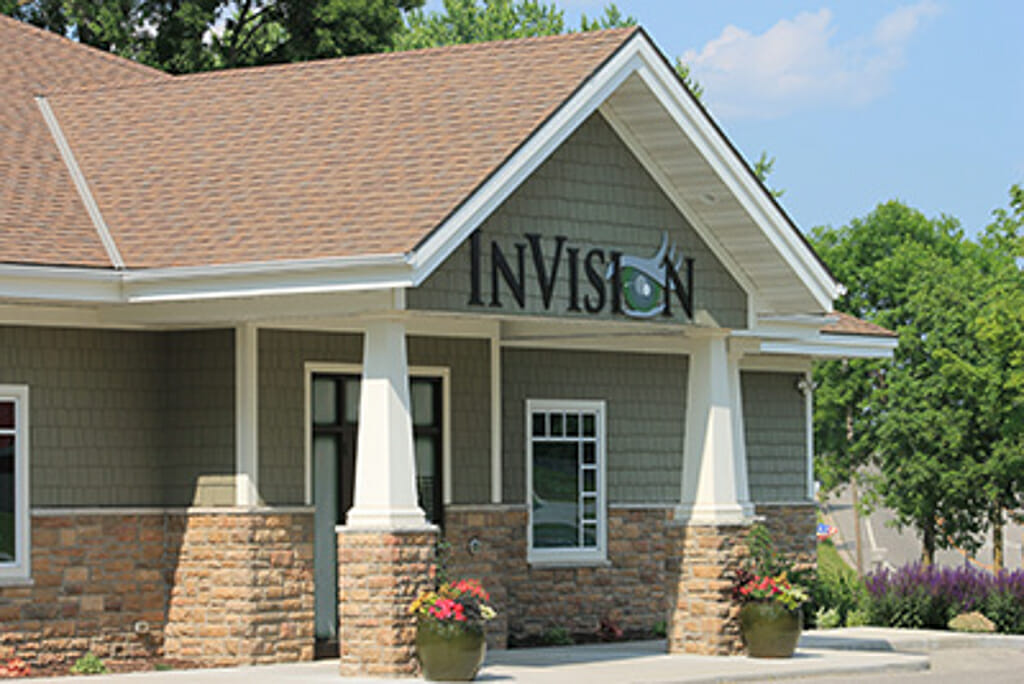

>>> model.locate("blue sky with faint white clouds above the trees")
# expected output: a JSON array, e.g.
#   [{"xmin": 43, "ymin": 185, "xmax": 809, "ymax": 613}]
[{"xmin": 427, "ymin": 0, "xmax": 1024, "ymax": 234}]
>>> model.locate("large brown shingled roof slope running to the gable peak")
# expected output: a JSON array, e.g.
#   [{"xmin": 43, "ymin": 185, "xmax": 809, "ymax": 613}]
[{"xmin": 36, "ymin": 29, "xmax": 635, "ymax": 268}]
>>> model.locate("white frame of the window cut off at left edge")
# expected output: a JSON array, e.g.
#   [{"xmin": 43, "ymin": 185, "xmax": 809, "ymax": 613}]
[{"xmin": 0, "ymin": 385, "xmax": 32, "ymax": 586}]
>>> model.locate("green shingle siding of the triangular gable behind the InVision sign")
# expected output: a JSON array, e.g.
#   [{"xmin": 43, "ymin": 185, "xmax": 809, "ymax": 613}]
[{"xmin": 407, "ymin": 114, "xmax": 746, "ymax": 328}]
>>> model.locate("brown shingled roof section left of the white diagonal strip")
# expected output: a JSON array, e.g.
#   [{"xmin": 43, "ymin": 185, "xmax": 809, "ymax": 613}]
[{"xmin": 0, "ymin": 15, "xmax": 170, "ymax": 266}]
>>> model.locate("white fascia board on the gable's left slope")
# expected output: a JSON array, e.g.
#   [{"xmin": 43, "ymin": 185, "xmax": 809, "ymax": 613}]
[{"xmin": 412, "ymin": 32, "xmax": 646, "ymax": 287}]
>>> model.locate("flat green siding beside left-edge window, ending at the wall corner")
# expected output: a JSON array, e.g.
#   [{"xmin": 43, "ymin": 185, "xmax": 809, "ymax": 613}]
[{"xmin": 0, "ymin": 327, "xmax": 165, "ymax": 507}]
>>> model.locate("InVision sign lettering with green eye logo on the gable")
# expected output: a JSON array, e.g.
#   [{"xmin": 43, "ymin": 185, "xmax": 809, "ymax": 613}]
[{"xmin": 468, "ymin": 231, "xmax": 693, "ymax": 319}]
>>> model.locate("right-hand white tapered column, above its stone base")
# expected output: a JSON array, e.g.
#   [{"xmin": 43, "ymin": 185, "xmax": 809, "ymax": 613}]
[{"xmin": 676, "ymin": 334, "xmax": 754, "ymax": 525}]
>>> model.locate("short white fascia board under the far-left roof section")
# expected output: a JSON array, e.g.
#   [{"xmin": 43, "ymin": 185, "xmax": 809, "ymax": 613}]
[{"xmin": 0, "ymin": 264, "xmax": 121, "ymax": 303}]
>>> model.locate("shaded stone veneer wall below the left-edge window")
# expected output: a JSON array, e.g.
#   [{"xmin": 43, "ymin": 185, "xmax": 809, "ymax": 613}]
[{"xmin": 0, "ymin": 513, "xmax": 174, "ymax": 666}]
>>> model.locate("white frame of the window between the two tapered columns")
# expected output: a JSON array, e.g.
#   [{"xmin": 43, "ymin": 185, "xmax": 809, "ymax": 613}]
[{"xmin": 525, "ymin": 399, "xmax": 608, "ymax": 566}]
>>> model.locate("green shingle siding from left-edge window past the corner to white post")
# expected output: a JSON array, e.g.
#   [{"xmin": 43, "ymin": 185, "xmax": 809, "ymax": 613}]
[{"xmin": 0, "ymin": 327, "xmax": 234, "ymax": 507}]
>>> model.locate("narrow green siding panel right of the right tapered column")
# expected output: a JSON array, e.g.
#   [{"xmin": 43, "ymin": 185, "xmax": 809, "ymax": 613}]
[{"xmin": 740, "ymin": 372, "xmax": 807, "ymax": 504}]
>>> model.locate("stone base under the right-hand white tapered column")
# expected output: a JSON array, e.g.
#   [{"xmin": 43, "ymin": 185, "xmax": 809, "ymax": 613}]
[{"xmin": 668, "ymin": 524, "xmax": 749, "ymax": 655}]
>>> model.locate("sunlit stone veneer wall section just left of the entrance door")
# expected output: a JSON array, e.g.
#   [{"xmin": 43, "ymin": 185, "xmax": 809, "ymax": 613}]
[{"xmin": 165, "ymin": 512, "xmax": 313, "ymax": 666}]
